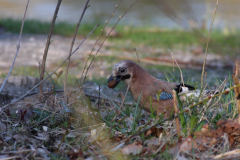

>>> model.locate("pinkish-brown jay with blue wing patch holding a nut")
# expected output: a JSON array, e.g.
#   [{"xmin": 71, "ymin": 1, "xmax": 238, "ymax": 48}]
[{"xmin": 108, "ymin": 60, "xmax": 195, "ymax": 118}]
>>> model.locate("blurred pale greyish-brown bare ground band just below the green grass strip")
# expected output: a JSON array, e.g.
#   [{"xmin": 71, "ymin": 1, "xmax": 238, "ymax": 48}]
[{"xmin": 0, "ymin": 32, "xmax": 232, "ymax": 71}]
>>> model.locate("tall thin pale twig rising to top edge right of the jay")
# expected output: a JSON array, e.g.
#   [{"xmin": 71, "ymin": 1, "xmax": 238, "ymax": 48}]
[{"xmin": 200, "ymin": 0, "xmax": 218, "ymax": 90}]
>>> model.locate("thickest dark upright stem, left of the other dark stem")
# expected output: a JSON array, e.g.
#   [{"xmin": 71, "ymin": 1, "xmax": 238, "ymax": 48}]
[{"xmin": 39, "ymin": 0, "xmax": 62, "ymax": 101}]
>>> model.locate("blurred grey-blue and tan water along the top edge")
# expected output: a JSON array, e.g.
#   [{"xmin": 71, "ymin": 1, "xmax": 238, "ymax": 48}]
[{"xmin": 0, "ymin": 0, "xmax": 240, "ymax": 30}]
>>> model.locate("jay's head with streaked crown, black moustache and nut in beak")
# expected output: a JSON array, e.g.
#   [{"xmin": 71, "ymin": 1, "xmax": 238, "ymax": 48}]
[{"xmin": 108, "ymin": 60, "xmax": 137, "ymax": 88}]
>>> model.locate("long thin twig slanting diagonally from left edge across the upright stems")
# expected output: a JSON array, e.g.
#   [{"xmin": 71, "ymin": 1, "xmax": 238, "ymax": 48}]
[{"xmin": 1, "ymin": 24, "xmax": 99, "ymax": 109}]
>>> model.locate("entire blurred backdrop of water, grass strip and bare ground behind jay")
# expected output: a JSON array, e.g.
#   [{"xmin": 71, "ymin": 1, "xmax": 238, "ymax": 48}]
[{"xmin": 0, "ymin": 0, "xmax": 240, "ymax": 89}]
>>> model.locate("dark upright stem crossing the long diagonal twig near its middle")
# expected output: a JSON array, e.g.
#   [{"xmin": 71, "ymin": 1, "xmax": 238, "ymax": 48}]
[{"xmin": 63, "ymin": 0, "xmax": 90, "ymax": 103}]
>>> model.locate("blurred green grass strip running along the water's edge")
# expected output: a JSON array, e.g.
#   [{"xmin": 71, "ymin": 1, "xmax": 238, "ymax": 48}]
[{"xmin": 0, "ymin": 19, "xmax": 240, "ymax": 55}]
